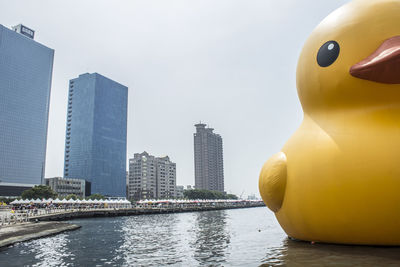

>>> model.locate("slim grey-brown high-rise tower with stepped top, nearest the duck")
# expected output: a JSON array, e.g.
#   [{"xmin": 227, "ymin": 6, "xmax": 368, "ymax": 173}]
[{"xmin": 194, "ymin": 123, "xmax": 224, "ymax": 192}]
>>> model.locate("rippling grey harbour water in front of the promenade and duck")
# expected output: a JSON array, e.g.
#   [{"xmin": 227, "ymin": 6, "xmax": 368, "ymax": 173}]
[{"xmin": 0, "ymin": 208, "xmax": 400, "ymax": 266}]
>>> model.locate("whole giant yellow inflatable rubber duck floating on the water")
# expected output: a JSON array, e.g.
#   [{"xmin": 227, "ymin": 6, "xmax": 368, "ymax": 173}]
[{"xmin": 259, "ymin": 0, "xmax": 400, "ymax": 245}]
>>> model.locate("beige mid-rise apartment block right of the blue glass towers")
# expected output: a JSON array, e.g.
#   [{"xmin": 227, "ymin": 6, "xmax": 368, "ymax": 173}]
[{"xmin": 128, "ymin": 151, "xmax": 176, "ymax": 200}]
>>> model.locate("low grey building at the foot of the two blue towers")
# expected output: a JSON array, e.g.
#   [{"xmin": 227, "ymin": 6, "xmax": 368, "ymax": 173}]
[{"xmin": 45, "ymin": 177, "xmax": 91, "ymax": 197}]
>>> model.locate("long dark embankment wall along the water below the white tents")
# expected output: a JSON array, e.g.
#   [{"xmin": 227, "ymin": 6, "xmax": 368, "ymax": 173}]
[{"xmin": 29, "ymin": 203, "xmax": 265, "ymax": 221}]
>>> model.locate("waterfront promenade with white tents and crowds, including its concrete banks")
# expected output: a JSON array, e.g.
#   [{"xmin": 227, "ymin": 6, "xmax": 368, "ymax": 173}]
[{"xmin": 0, "ymin": 200, "xmax": 264, "ymax": 251}]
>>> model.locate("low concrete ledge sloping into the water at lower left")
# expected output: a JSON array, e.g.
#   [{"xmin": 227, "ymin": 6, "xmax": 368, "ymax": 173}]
[{"xmin": 0, "ymin": 222, "xmax": 80, "ymax": 248}]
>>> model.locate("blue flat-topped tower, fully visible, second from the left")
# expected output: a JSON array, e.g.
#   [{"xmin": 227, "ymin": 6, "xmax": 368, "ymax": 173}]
[{"xmin": 64, "ymin": 73, "xmax": 128, "ymax": 196}]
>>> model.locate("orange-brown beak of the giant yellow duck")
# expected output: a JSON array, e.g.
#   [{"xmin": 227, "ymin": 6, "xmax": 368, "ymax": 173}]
[{"xmin": 350, "ymin": 36, "xmax": 400, "ymax": 84}]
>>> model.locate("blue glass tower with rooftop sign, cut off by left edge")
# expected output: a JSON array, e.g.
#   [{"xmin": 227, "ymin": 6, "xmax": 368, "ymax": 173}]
[{"xmin": 0, "ymin": 24, "xmax": 54, "ymax": 196}]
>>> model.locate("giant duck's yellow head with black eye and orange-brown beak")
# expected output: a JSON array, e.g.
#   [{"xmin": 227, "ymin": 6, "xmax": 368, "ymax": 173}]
[{"xmin": 297, "ymin": 0, "xmax": 400, "ymax": 113}]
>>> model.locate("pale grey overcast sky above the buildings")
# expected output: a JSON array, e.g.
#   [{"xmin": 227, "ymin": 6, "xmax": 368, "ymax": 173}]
[{"xmin": 0, "ymin": 0, "xmax": 348, "ymax": 199}]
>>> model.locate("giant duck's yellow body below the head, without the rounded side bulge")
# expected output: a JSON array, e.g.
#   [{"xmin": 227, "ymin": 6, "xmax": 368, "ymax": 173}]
[{"xmin": 276, "ymin": 109, "xmax": 400, "ymax": 245}]
